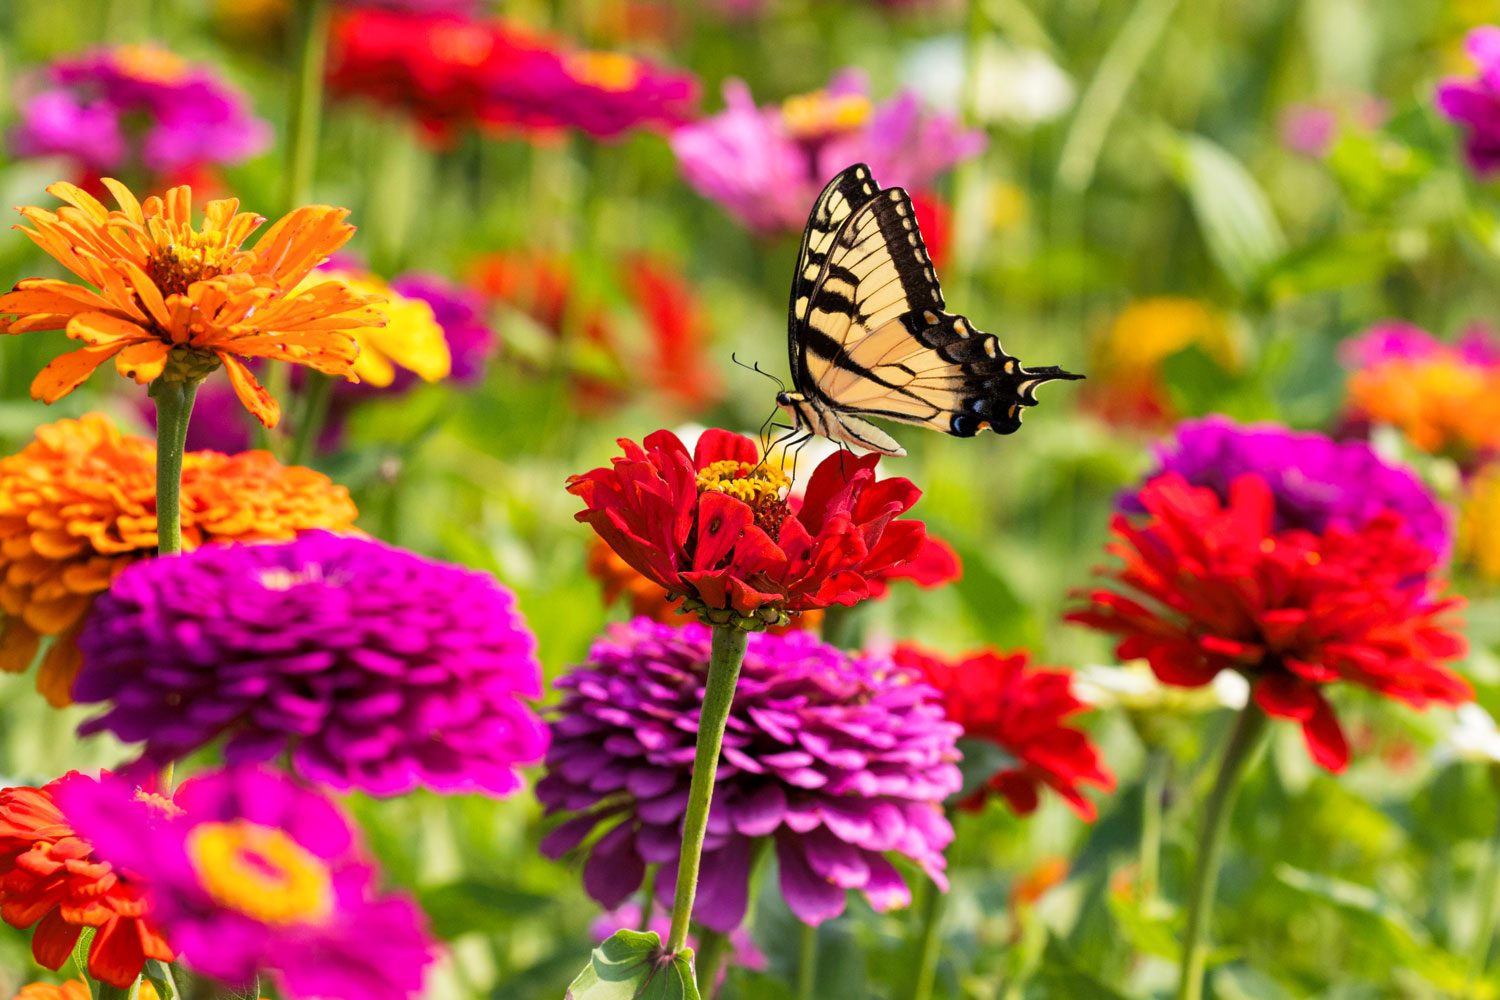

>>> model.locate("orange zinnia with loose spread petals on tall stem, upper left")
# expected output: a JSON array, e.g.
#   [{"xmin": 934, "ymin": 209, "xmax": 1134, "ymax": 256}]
[{"xmin": 0, "ymin": 178, "xmax": 383, "ymax": 427}]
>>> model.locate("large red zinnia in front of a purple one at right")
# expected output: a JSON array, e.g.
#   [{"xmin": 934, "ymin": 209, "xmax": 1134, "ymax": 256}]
[{"xmin": 1068, "ymin": 474, "xmax": 1473, "ymax": 772}]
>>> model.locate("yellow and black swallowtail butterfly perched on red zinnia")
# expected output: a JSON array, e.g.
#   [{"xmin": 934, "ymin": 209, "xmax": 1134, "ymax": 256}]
[{"xmin": 776, "ymin": 163, "xmax": 1083, "ymax": 456}]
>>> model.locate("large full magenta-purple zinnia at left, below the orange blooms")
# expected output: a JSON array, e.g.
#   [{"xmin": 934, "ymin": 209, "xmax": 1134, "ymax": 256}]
[{"xmin": 74, "ymin": 532, "xmax": 548, "ymax": 795}]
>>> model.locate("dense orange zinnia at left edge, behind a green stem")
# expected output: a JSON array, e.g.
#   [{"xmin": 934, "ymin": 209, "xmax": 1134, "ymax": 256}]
[{"xmin": 0, "ymin": 414, "xmax": 359, "ymax": 706}]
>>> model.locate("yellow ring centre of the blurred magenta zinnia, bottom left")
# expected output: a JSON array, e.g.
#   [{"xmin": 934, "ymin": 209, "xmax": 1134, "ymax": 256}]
[{"xmin": 188, "ymin": 820, "xmax": 333, "ymax": 925}]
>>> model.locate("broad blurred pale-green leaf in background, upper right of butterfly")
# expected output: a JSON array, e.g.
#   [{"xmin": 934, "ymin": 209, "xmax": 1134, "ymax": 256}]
[{"xmin": 1167, "ymin": 135, "xmax": 1287, "ymax": 292}]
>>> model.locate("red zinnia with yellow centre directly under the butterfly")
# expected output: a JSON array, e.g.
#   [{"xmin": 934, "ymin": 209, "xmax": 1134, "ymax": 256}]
[{"xmin": 569, "ymin": 430, "xmax": 927, "ymax": 625}]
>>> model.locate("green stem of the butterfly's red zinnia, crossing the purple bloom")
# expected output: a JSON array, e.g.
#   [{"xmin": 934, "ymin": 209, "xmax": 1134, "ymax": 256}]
[{"xmin": 666, "ymin": 625, "xmax": 750, "ymax": 954}]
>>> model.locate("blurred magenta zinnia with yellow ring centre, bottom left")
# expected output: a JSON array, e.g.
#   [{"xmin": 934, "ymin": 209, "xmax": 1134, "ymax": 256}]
[{"xmin": 59, "ymin": 768, "xmax": 434, "ymax": 1000}]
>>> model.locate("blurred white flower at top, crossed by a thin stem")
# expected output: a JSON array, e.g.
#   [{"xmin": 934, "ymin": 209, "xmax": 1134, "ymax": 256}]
[{"xmin": 902, "ymin": 34, "xmax": 1074, "ymax": 124}]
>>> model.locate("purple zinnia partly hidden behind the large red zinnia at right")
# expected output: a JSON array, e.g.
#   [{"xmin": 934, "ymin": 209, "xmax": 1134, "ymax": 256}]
[{"xmin": 1121, "ymin": 415, "xmax": 1452, "ymax": 561}]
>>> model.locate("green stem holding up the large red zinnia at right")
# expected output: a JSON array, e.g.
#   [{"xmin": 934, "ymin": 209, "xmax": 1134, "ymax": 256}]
[{"xmin": 1178, "ymin": 700, "xmax": 1266, "ymax": 1000}]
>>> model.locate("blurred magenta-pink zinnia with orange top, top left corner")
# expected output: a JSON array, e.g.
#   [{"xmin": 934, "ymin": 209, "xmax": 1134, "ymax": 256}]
[{"xmin": 11, "ymin": 45, "xmax": 272, "ymax": 177}]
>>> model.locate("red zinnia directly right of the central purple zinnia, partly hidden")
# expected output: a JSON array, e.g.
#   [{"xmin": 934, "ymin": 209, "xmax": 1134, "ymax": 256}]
[{"xmin": 896, "ymin": 646, "xmax": 1115, "ymax": 822}]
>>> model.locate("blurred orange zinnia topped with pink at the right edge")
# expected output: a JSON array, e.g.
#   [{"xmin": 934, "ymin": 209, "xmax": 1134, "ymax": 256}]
[{"xmin": 1340, "ymin": 324, "xmax": 1500, "ymax": 462}]
